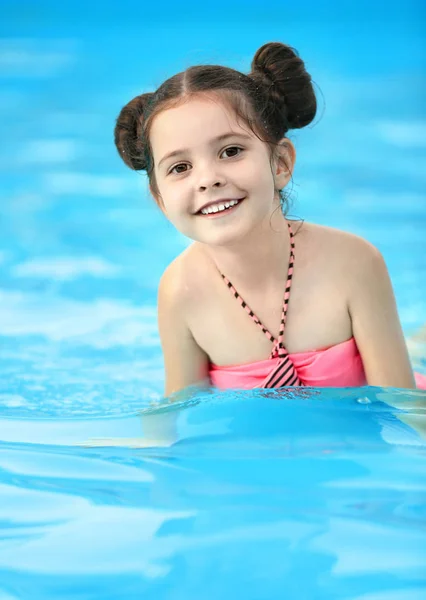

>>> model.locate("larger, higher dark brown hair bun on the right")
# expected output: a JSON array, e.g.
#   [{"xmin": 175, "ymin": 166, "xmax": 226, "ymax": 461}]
[{"xmin": 250, "ymin": 42, "xmax": 317, "ymax": 130}]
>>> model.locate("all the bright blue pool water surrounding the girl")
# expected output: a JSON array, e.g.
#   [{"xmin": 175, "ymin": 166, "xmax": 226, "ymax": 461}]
[{"xmin": 0, "ymin": 0, "xmax": 426, "ymax": 600}]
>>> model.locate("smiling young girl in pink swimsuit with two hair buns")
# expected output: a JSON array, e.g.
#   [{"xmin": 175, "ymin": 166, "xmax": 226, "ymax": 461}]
[{"xmin": 115, "ymin": 43, "xmax": 426, "ymax": 395}]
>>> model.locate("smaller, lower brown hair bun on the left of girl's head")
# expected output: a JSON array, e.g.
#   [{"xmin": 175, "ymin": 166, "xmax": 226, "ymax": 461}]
[{"xmin": 114, "ymin": 93, "xmax": 153, "ymax": 171}]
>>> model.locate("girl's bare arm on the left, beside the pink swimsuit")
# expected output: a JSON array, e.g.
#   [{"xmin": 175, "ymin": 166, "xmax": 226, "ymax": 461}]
[{"xmin": 158, "ymin": 263, "xmax": 209, "ymax": 396}]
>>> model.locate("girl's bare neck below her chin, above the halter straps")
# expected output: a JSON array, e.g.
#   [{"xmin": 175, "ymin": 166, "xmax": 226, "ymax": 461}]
[{"xmin": 205, "ymin": 210, "xmax": 290, "ymax": 290}]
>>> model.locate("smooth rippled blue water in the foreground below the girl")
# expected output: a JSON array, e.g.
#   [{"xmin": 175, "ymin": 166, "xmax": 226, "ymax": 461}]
[{"xmin": 0, "ymin": 388, "xmax": 426, "ymax": 599}]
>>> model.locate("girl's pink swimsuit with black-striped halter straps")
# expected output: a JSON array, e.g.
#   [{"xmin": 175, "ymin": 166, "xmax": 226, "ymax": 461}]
[{"xmin": 209, "ymin": 223, "xmax": 426, "ymax": 389}]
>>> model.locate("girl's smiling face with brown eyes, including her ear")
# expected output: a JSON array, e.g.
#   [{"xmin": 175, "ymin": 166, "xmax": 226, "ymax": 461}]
[{"xmin": 150, "ymin": 95, "xmax": 290, "ymax": 245}]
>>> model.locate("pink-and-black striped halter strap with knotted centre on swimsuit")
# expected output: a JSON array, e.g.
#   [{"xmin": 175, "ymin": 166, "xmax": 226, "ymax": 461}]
[{"xmin": 221, "ymin": 223, "xmax": 303, "ymax": 388}]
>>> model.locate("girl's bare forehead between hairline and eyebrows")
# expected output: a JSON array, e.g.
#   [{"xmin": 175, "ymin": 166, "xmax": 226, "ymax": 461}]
[{"xmin": 150, "ymin": 97, "xmax": 253, "ymax": 156}]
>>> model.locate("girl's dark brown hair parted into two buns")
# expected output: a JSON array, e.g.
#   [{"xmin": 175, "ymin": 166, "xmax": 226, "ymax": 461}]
[{"xmin": 114, "ymin": 42, "xmax": 317, "ymax": 206}]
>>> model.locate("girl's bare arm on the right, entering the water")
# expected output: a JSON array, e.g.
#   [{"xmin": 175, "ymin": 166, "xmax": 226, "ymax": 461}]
[{"xmin": 349, "ymin": 240, "xmax": 416, "ymax": 388}]
